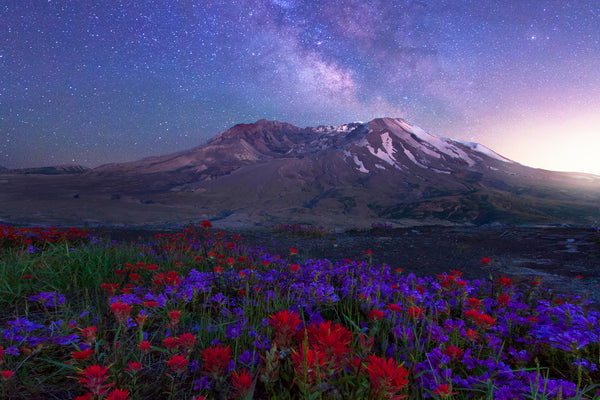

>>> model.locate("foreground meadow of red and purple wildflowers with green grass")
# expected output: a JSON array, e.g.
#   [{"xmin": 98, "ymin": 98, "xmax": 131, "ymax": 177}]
[{"xmin": 0, "ymin": 223, "xmax": 600, "ymax": 400}]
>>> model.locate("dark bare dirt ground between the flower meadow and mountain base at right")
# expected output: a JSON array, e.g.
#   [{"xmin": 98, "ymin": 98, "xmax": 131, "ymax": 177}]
[{"xmin": 94, "ymin": 226, "xmax": 600, "ymax": 305}]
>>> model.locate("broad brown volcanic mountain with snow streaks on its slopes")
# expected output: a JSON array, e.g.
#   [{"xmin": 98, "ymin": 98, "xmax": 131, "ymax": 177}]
[{"xmin": 1, "ymin": 118, "xmax": 600, "ymax": 226}]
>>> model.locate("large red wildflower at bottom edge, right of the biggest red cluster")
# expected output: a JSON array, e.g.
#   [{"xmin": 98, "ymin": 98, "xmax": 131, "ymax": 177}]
[{"xmin": 367, "ymin": 354, "xmax": 408, "ymax": 399}]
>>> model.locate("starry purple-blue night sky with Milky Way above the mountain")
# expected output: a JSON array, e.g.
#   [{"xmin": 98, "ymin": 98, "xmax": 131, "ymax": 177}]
[{"xmin": 0, "ymin": 0, "xmax": 600, "ymax": 174}]
